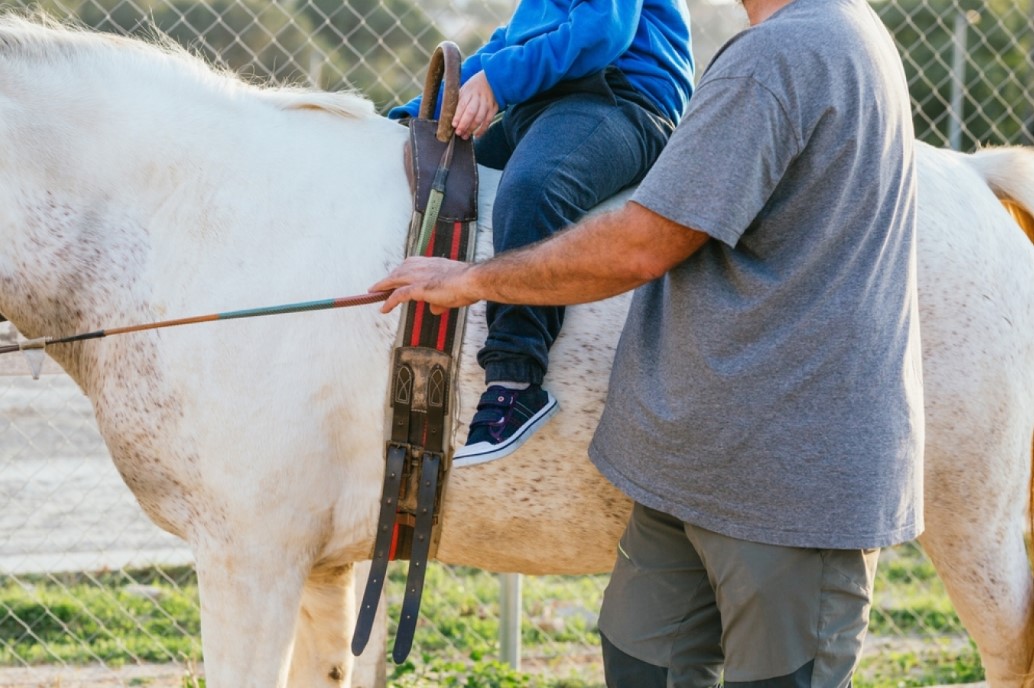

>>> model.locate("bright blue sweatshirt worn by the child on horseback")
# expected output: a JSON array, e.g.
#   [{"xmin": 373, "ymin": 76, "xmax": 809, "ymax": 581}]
[{"xmin": 388, "ymin": 0, "xmax": 693, "ymax": 124}]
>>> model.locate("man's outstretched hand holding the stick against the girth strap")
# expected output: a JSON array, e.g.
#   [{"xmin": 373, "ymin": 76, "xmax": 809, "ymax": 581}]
[{"xmin": 369, "ymin": 257, "xmax": 478, "ymax": 316}]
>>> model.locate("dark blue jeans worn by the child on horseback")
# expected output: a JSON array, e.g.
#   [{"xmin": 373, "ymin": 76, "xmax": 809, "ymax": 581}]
[{"xmin": 475, "ymin": 68, "xmax": 673, "ymax": 384}]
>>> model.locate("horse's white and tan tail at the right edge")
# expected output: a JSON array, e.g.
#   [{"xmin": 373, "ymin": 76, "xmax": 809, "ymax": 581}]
[{"xmin": 967, "ymin": 146, "xmax": 1034, "ymax": 688}]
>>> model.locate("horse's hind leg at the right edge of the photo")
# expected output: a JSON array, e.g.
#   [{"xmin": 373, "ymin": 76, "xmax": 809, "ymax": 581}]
[{"xmin": 919, "ymin": 438, "xmax": 1034, "ymax": 688}]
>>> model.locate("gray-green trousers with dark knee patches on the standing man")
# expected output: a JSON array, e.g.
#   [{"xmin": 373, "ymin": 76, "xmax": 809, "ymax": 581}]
[{"xmin": 600, "ymin": 504, "xmax": 879, "ymax": 688}]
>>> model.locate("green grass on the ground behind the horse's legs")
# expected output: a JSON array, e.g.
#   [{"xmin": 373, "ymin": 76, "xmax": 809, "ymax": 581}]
[{"xmin": 0, "ymin": 545, "xmax": 983, "ymax": 688}]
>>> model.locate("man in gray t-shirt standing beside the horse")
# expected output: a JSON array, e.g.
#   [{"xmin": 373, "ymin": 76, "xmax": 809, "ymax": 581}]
[{"xmin": 373, "ymin": 0, "xmax": 922, "ymax": 688}]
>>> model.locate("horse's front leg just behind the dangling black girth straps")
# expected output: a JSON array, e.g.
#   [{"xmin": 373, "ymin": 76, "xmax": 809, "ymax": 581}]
[{"xmin": 288, "ymin": 562, "xmax": 387, "ymax": 688}]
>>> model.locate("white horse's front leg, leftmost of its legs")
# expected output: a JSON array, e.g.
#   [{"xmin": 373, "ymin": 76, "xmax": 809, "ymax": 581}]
[{"xmin": 194, "ymin": 540, "xmax": 306, "ymax": 688}]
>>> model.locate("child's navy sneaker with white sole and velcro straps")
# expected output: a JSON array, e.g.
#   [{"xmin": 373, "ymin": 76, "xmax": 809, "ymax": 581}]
[{"xmin": 453, "ymin": 385, "xmax": 558, "ymax": 467}]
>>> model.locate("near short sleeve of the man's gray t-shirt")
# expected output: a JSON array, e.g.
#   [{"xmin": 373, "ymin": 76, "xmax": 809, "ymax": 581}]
[{"xmin": 632, "ymin": 77, "xmax": 802, "ymax": 246}]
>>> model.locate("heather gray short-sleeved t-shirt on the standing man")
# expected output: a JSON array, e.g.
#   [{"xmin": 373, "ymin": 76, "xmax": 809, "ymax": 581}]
[{"xmin": 590, "ymin": 0, "xmax": 923, "ymax": 548}]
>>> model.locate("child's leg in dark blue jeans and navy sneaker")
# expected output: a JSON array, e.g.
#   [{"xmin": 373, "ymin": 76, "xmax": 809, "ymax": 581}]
[{"xmin": 453, "ymin": 79, "xmax": 669, "ymax": 467}]
